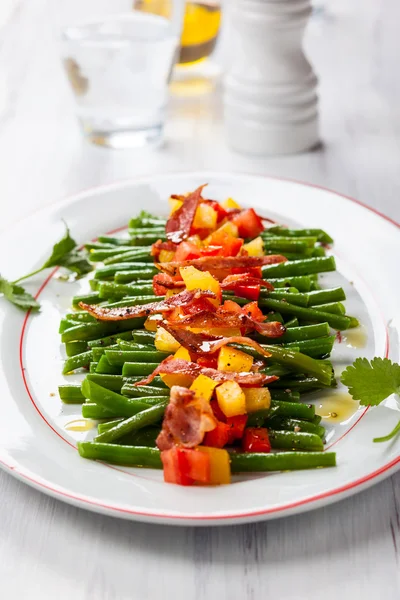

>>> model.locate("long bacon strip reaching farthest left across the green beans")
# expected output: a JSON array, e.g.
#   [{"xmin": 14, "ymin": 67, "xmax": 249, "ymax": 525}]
[{"xmin": 79, "ymin": 290, "xmax": 216, "ymax": 321}]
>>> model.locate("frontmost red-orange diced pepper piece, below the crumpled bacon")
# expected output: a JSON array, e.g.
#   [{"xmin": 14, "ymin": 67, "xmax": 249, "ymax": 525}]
[{"xmin": 161, "ymin": 446, "xmax": 211, "ymax": 485}]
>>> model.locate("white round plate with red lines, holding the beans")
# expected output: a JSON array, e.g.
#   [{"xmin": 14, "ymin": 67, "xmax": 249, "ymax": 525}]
[{"xmin": 0, "ymin": 172, "xmax": 400, "ymax": 525}]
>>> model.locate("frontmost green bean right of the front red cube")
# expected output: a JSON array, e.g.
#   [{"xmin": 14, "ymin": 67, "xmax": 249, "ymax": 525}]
[{"xmin": 230, "ymin": 450, "xmax": 336, "ymax": 473}]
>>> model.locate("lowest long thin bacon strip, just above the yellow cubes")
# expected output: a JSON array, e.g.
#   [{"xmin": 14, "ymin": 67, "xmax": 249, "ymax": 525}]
[{"xmin": 134, "ymin": 356, "xmax": 278, "ymax": 387}]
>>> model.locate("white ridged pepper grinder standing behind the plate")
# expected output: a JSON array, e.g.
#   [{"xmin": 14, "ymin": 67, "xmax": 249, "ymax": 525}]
[{"xmin": 224, "ymin": 0, "xmax": 319, "ymax": 156}]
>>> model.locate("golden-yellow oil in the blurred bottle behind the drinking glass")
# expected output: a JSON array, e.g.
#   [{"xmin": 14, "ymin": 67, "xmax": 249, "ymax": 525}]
[{"xmin": 133, "ymin": 0, "xmax": 221, "ymax": 65}]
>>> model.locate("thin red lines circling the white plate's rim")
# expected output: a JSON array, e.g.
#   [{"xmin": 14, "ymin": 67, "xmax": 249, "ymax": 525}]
[{"xmin": 0, "ymin": 172, "xmax": 400, "ymax": 521}]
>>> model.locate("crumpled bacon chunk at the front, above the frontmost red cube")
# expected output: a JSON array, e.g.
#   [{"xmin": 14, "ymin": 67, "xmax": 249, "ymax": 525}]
[{"xmin": 156, "ymin": 385, "xmax": 217, "ymax": 450}]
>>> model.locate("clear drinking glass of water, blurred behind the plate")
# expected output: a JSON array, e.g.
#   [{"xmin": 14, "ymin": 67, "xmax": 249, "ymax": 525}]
[{"xmin": 62, "ymin": 9, "xmax": 184, "ymax": 148}]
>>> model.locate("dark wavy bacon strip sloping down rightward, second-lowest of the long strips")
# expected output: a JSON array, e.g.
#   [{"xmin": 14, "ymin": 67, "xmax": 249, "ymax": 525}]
[{"xmin": 161, "ymin": 321, "xmax": 271, "ymax": 358}]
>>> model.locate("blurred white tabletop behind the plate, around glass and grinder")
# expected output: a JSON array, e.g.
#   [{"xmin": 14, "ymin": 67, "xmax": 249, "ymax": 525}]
[{"xmin": 0, "ymin": 0, "xmax": 400, "ymax": 227}]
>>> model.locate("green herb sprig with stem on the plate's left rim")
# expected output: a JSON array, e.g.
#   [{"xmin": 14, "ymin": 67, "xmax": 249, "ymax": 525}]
[{"xmin": 0, "ymin": 226, "xmax": 92, "ymax": 310}]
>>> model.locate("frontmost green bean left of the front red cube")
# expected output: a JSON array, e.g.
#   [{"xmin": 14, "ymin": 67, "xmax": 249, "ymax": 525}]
[{"xmin": 78, "ymin": 442, "xmax": 162, "ymax": 469}]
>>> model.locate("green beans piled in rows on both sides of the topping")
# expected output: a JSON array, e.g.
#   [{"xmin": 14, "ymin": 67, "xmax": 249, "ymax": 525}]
[{"xmin": 59, "ymin": 213, "xmax": 350, "ymax": 472}]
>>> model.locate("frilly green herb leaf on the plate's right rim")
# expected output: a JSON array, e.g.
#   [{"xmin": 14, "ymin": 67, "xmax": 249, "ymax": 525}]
[{"xmin": 341, "ymin": 358, "xmax": 400, "ymax": 406}]
